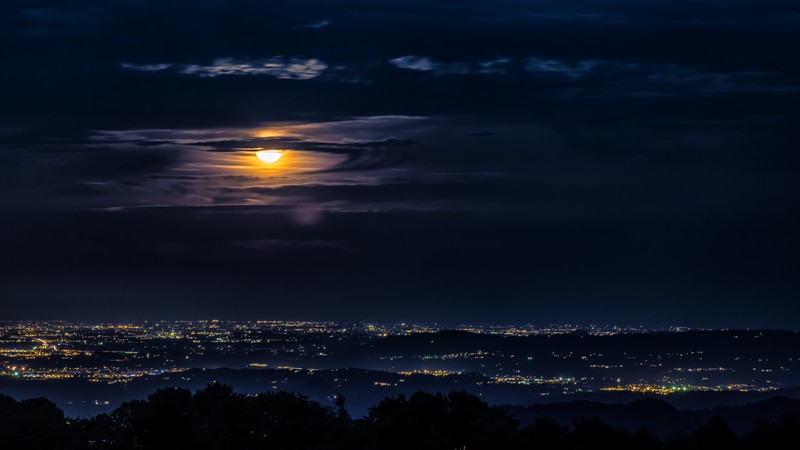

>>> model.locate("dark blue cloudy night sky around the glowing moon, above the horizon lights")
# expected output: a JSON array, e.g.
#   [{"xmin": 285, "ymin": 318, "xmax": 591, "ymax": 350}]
[{"xmin": 0, "ymin": 0, "xmax": 800, "ymax": 329}]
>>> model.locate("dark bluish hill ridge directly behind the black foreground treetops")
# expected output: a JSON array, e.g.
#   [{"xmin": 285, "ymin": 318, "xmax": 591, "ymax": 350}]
[{"xmin": 0, "ymin": 368, "xmax": 800, "ymax": 423}]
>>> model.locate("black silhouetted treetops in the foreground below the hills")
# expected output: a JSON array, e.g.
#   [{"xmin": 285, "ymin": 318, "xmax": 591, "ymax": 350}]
[{"xmin": 0, "ymin": 383, "xmax": 800, "ymax": 450}]
